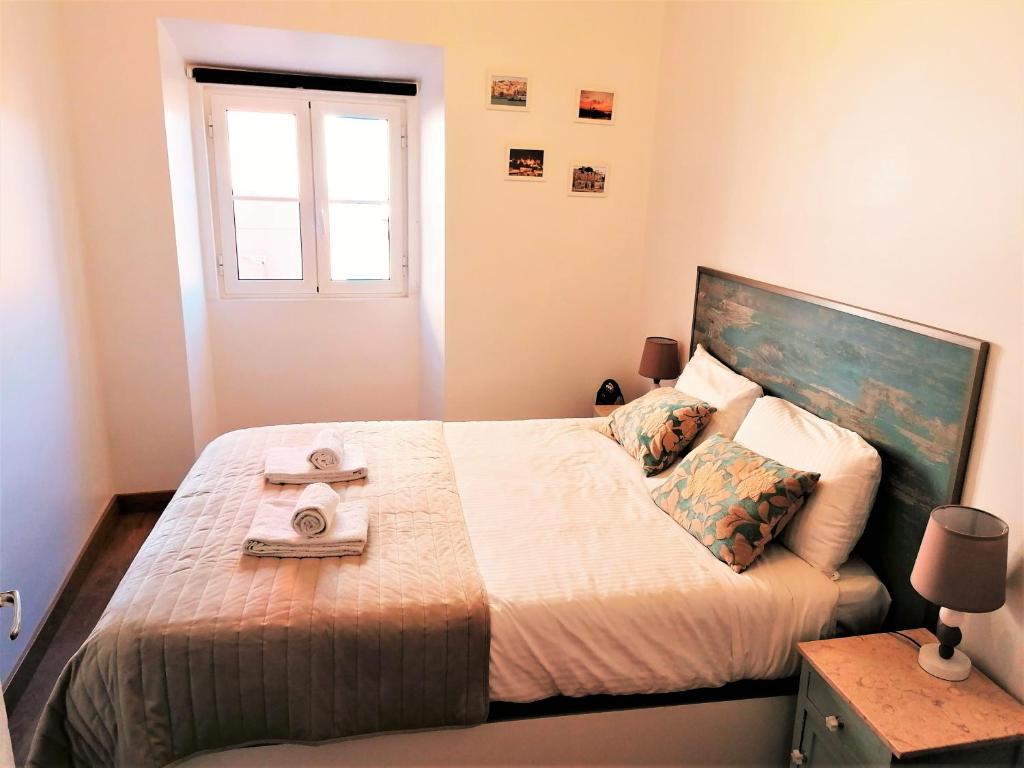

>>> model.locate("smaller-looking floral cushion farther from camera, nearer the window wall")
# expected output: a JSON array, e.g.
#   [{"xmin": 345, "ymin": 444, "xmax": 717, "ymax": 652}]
[{"xmin": 605, "ymin": 387, "xmax": 715, "ymax": 475}]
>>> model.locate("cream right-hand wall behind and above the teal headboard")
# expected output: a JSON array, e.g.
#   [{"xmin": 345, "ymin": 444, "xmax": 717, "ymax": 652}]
[{"xmin": 641, "ymin": 1, "xmax": 1024, "ymax": 697}]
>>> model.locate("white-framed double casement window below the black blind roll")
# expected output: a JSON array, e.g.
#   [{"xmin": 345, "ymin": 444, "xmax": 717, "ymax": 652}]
[{"xmin": 207, "ymin": 88, "xmax": 408, "ymax": 296}]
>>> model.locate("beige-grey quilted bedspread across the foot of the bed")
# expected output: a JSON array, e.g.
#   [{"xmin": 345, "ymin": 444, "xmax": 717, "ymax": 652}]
[{"xmin": 29, "ymin": 422, "xmax": 489, "ymax": 766}]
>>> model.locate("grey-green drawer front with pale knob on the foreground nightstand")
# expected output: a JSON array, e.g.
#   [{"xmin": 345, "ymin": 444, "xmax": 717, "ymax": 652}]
[{"xmin": 801, "ymin": 665, "xmax": 892, "ymax": 765}]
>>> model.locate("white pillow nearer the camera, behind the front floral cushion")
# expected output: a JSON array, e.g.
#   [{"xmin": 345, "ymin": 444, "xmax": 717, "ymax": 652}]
[{"xmin": 735, "ymin": 397, "xmax": 882, "ymax": 574}]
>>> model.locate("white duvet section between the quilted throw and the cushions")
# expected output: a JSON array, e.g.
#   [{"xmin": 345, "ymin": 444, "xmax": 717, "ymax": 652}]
[{"xmin": 444, "ymin": 419, "xmax": 839, "ymax": 701}]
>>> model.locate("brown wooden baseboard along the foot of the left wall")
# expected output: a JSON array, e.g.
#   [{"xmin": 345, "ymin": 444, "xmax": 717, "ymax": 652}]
[{"xmin": 3, "ymin": 490, "xmax": 174, "ymax": 712}]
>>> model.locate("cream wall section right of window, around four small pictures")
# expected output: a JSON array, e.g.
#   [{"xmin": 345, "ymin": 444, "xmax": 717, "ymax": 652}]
[{"xmin": 434, "ymin": 2, "xmax": 665, "ymax": 420}]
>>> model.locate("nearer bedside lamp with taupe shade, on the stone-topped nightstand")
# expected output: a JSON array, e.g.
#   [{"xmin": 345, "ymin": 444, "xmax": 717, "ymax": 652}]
[{"xmin": 910, "ymin": 505, "xmax": 1010, "ymax": 681}]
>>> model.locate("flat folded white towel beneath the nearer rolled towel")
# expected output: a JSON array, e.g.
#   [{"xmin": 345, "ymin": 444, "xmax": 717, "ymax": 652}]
[{"xmin": 242, "ymin": 499, "xmax": 370, "ymax": 557}]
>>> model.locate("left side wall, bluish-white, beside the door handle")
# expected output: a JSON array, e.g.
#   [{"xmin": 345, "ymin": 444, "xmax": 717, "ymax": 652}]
[{"xmin": 0, "ymin": 3, "xmax": 114, "ymax": 680}]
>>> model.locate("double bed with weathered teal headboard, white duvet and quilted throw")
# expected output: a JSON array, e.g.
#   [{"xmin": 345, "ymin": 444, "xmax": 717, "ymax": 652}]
[{"xmin": 30, "ymin": 269, "xmax": 985, "ymax": 765}]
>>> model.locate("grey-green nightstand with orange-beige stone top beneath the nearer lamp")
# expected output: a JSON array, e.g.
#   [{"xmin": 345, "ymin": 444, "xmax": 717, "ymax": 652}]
[{"xmin": 790, "ymin": 630, "xmax": 1024, "ymax": 766}]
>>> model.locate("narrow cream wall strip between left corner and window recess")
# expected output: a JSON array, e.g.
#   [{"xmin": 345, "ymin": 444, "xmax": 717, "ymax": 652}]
[{"xmin": 58, "ymin": 3, "xmax": 195, "ymax": 493}]
